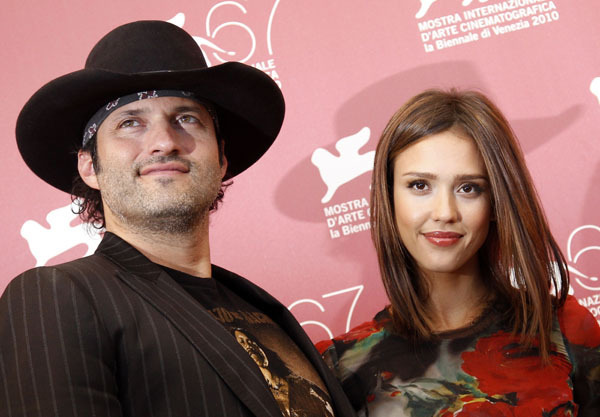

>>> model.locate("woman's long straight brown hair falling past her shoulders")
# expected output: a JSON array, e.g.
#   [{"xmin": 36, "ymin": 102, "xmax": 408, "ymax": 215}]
[{"xmin": 371, "ymin": 90, "xmax": 569, "ymax": 360}]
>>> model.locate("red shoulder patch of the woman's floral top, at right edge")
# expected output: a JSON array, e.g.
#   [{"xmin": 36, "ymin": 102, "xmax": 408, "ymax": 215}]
[{"xmin": 557, "ymin": 295, "xmax": 600, "ymax": 348}]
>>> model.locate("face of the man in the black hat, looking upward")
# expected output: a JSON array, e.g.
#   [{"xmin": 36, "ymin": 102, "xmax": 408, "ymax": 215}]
[{"xmin": 80, "ymin": 97, "xmax": 227, "ymax": 233}]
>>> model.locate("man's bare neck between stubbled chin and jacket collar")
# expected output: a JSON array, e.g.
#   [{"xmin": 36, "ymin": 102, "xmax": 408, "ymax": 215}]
[{"xmin": 106, "ymin": 216, "xmax": 211, "ymax": 278}]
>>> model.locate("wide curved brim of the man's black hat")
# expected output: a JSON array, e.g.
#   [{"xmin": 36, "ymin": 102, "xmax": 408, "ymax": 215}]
[{"xmin": 16, "ymin": 62, "xmax": 285, "ymax": 193}]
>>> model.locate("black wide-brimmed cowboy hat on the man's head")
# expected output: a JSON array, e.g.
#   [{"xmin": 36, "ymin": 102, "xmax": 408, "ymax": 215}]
[{"xmin": 16, "ymin": 20, "xmax": 285, "ymax": 193}]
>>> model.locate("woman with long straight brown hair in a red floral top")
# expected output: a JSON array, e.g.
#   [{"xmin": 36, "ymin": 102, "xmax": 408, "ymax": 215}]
[{"xmin": 318, "ymin": 90, "xmax": 600, "ymax": 417}]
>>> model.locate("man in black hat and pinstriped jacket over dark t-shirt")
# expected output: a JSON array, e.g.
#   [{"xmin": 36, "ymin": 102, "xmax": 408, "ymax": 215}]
[{"xmin": 0, "ymin": 21, "xmax": 353, "ymax": 417}]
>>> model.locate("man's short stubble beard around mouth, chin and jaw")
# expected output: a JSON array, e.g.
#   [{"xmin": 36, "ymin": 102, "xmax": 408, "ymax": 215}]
[{"xmin": 96, "ymin": 156, "xmax": 221, "ymax": 235}]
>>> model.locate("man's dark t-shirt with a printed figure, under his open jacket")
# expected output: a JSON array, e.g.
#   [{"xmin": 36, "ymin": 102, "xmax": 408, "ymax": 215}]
[{"xmin": 164, "ymin": 268, "xmax": 334, "ymax": 417}]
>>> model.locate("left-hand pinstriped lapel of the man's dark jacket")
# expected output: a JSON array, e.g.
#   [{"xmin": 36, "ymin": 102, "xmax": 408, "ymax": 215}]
[{"xmin": 97, "ymin": 233, "xmax": 281, "ymax": 417}]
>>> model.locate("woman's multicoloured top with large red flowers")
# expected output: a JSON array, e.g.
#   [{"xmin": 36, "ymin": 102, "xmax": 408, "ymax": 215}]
[{"xmin": 317, "ymin": 297, "xmax": 600, "ymax": 417}]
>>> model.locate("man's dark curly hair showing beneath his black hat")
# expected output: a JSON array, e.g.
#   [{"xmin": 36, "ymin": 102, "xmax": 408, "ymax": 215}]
[{"xmin": 71, "ymin": 135, "xmax": 232, "ymax": 229}]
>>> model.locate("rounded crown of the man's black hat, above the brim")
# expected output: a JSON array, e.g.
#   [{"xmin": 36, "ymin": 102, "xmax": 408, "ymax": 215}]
[{"xmin": 85, "ymin": 20, "xmax": 207, "ymax": 74}]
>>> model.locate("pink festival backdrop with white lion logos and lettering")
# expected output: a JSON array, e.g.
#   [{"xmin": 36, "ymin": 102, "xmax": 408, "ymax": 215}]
[{"xmin": 0, "ymin": 0, "xmax": 600, "ymax": 341}]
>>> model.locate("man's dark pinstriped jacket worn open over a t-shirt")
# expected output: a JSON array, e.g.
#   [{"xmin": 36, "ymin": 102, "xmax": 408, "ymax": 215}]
[{"xmin": 0, "ymin": 233, "xmax": 354, "ymax": 417}]
